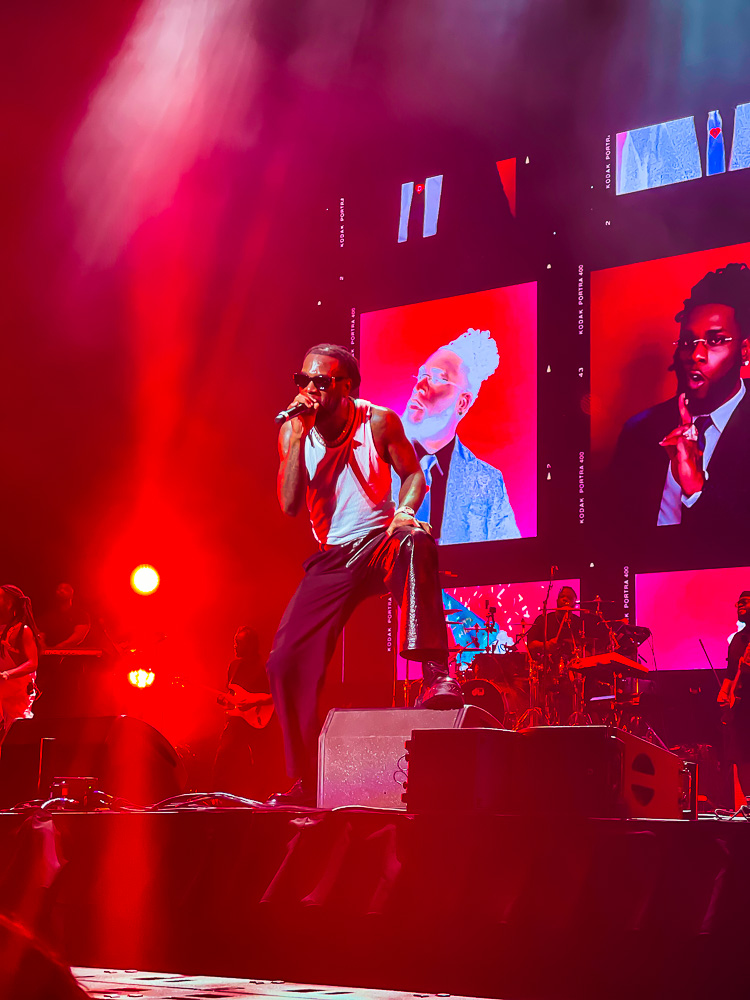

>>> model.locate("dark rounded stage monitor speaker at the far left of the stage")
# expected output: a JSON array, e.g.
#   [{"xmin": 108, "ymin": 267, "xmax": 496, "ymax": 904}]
[{"xmin": 0, "ymin": 715, "xmax": 186, "ymax": 808}]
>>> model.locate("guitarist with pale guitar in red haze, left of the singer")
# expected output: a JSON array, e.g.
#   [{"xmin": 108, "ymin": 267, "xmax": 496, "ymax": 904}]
[{"xmin": 213, "ymin": 625, "xmax": 283, "ymax": 800}]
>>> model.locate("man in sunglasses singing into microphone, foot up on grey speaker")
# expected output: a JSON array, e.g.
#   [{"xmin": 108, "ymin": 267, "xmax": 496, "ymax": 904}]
[{"xmin": 267, "ymin": 344, "xmax": 461, "ymax": 806}]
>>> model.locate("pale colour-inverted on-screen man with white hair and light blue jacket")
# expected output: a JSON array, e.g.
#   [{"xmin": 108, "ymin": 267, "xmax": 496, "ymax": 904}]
[{"xmin": 403, "ymin": 329, "xmax": 520, "ymax": 545}]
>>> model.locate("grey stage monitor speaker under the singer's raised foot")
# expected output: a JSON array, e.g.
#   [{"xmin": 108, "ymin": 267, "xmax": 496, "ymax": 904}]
[{"xmin": 318, "ymin": 705, "xmax": 500, "ymax": 809}]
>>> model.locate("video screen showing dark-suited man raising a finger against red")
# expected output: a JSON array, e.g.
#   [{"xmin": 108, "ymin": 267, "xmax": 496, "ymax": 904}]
[{"xmin": 590, "ymin": 243, "xmax": 750, "ymax": 537}]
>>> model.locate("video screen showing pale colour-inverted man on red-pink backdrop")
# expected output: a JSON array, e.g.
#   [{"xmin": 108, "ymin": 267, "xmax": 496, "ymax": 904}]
[{"xmin": 360, "ymin": 282, "xmax": 537, "ymax": 545}]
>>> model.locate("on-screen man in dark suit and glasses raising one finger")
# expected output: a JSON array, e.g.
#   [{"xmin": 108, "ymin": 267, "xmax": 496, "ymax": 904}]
[{"xmin": 612, "ymin": 264, "xmax": 750, "ymax": 533}]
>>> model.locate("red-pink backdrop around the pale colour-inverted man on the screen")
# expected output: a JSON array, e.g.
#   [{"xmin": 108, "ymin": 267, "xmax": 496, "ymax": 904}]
[{"xmin": 360, "ymin": 281, "xmax": 537, "ymax": 538}]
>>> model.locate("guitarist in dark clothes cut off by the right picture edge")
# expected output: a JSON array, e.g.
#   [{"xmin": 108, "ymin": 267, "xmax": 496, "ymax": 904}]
[{"xmin": 717, "ymin": 590, "xmax": 750, "ymax": 795}]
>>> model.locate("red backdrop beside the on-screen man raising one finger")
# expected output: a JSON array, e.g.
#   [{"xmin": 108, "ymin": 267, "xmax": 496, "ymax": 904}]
[{"xmin": 591, "ymin": 243, "xmax": 750, "ymax": 468}]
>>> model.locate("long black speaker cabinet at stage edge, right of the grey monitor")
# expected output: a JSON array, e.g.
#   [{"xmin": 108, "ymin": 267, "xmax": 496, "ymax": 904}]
[{"xmin": 406, "ymin": 726, "xmax": 696, "ymax": 819}]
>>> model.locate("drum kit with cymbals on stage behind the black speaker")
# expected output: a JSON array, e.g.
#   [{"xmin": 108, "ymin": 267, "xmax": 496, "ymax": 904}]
[{"xmin": 445, "ymin": 597, "xmax": 662, "ymax": 745}]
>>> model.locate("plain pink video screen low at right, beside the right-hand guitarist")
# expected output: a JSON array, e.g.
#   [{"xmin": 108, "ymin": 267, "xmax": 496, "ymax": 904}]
[{"xmin": 635, "ymin": 566, "xmax": 750, "ymax": 676}]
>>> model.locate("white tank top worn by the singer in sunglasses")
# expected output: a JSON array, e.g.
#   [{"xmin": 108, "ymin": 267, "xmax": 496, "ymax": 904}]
[{"xmin": 305, "ymin": 399, "xmax": 396, "ymax": 548}]
